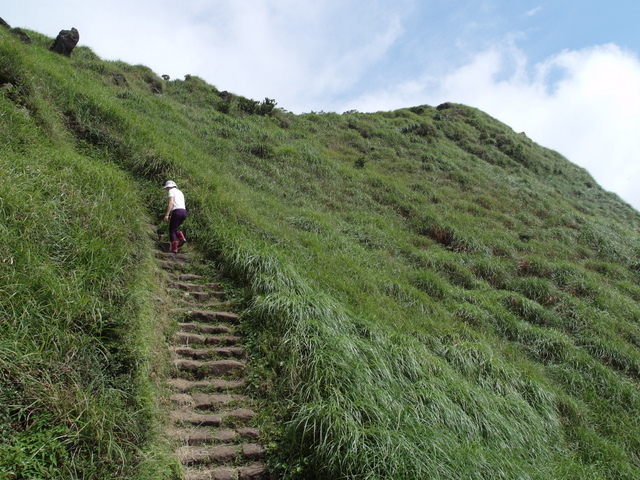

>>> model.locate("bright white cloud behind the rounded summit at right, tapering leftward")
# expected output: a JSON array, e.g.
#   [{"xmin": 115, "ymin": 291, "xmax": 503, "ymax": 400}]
[{"xmin": 342, "ymin": 44, "xmax": 640, "ymax": 209}]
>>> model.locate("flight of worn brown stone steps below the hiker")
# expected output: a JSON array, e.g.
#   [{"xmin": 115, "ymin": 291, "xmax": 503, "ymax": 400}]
[{"xmin": 157, "ymin": 248, "xmax": 269, "ymax": 480}]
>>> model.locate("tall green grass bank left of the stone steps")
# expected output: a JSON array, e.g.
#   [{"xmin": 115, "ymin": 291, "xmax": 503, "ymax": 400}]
[{"xmin": 0, "ymin": 31, "xmax": 175, "ymax": 479}]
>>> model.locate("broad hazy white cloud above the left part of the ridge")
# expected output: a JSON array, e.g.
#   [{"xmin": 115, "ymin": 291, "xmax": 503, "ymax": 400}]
[{"xmin": 6, "ymin": 0, "xmax": 415, "ymax": 108}]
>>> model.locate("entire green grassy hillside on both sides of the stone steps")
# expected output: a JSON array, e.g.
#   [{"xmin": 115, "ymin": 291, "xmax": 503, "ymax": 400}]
[{"xmin": 0, "ymin": 23, "xmax": 640, "ymax": 480}]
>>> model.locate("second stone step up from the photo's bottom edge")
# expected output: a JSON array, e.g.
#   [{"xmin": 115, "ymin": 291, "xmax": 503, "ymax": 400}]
[{"xmin": 176, "ymin": 443, "xmax": 265, "ymax": 465}]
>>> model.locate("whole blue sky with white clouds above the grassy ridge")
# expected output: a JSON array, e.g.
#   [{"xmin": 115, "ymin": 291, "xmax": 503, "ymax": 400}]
[{"xmin": 5, "ymin": 0, "xmax": 640, "ymax": 210}]
